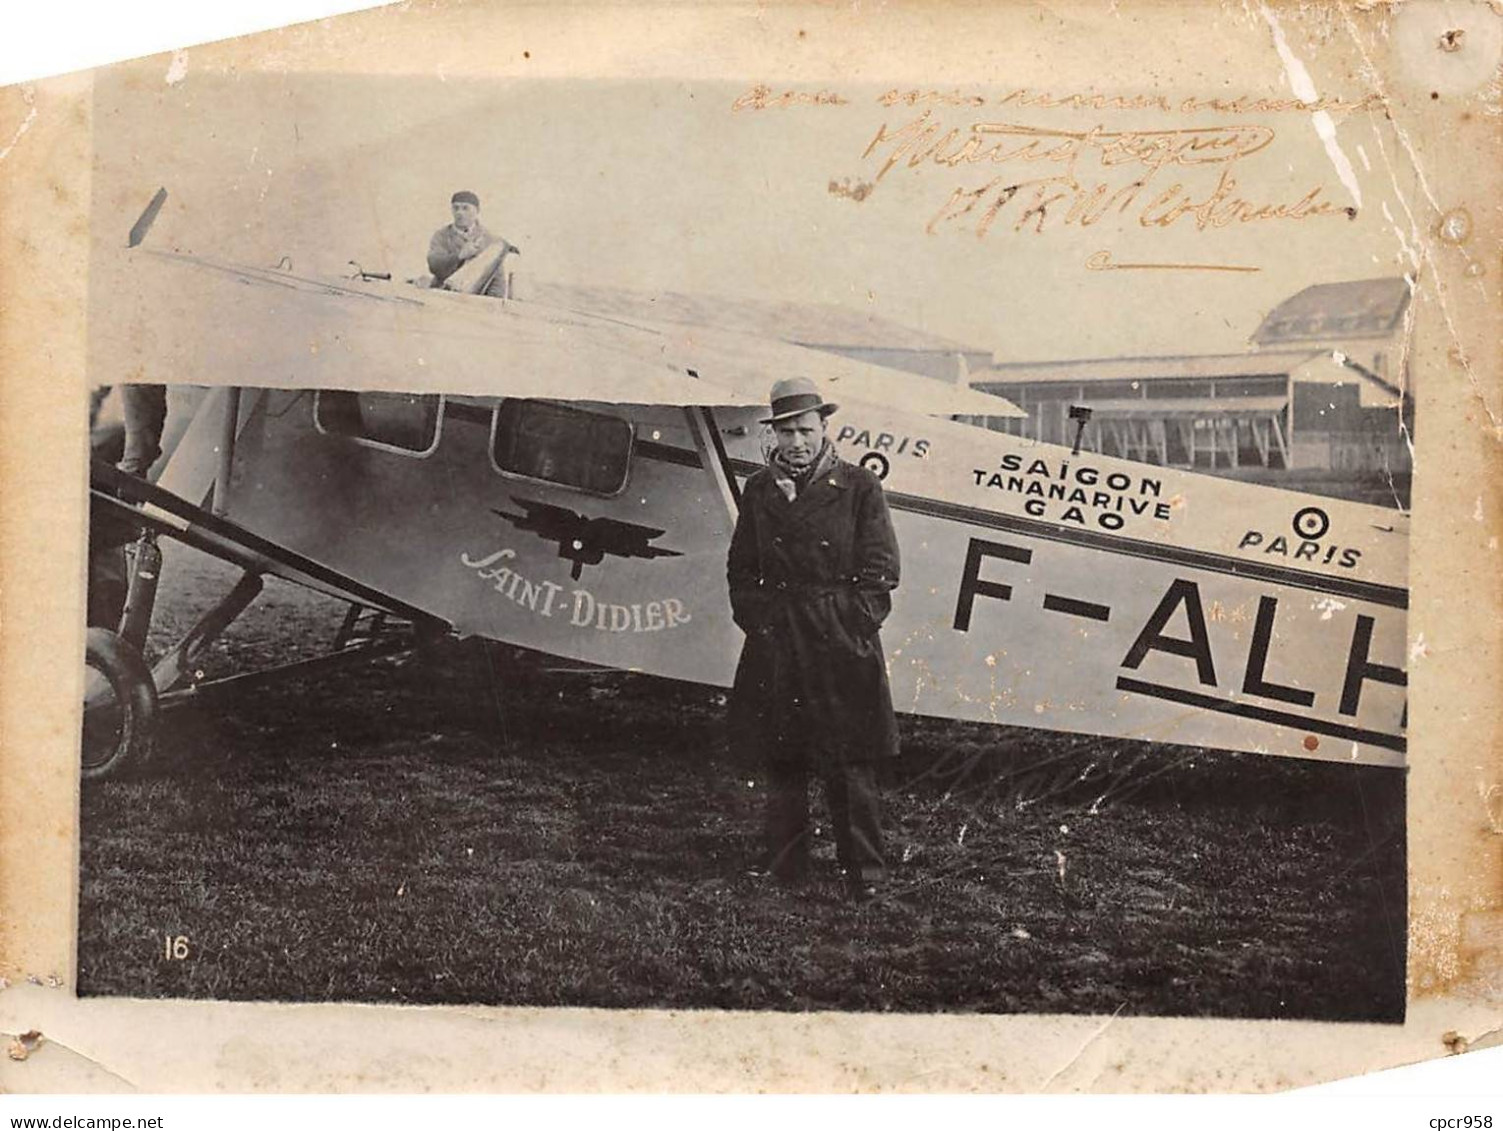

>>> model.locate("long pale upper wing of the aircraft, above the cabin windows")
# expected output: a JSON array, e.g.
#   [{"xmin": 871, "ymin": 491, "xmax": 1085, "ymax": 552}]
[{"xmin": 90, "ymin": 247, "xmax": 1021, "ymax": 417}]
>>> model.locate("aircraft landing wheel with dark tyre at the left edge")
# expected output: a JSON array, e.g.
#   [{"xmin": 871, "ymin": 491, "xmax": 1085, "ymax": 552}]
[{"xmin": 81, "ymin": 629, "xmax": 156, "ymax": 781}]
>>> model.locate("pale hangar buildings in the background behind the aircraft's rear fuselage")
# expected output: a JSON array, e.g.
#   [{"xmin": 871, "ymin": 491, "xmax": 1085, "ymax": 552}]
[{"xmin": 971, "ymin": 278, "xmax": 1413, "ymax": 478}]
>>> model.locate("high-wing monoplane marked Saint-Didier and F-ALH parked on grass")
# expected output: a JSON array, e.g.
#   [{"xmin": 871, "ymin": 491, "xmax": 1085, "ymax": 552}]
[{"xmin": 84, "ymin": 197, "xmax": 1408, "ymax": 776}]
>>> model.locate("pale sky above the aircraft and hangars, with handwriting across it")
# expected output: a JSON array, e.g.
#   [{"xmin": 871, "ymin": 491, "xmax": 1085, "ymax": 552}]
[{"xmin": 95, "ymin": 19, "xmax": 1413, "ymax": 361}]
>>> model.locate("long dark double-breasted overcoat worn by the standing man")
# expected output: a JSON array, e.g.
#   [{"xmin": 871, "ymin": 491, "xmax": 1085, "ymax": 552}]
[{"xmin": 726, "ymin": 460, "xmax": 899, "ymax": 761}]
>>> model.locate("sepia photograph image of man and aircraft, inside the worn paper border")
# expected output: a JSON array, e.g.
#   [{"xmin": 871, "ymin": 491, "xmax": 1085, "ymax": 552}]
[{"xmin": 67, "ymin": 41, "xmax": 1418, "ymax": 1024}]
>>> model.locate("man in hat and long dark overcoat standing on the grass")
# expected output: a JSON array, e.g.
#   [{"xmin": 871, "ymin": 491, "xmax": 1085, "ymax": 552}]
[{"xmin": 726, "ymin": 378, "xmax": 899, "ymax": 901}]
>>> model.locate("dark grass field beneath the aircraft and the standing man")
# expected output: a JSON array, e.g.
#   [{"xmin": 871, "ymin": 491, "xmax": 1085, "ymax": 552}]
[{"xmin": 78, "ymin": 553, "xmax": 1405, "ymax": 1021}]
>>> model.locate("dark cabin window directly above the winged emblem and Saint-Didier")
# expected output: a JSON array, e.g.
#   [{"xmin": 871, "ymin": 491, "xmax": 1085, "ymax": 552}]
[{"xmin": 490, "ymin": 400, "xmax": 631, "ymax": 495}]
